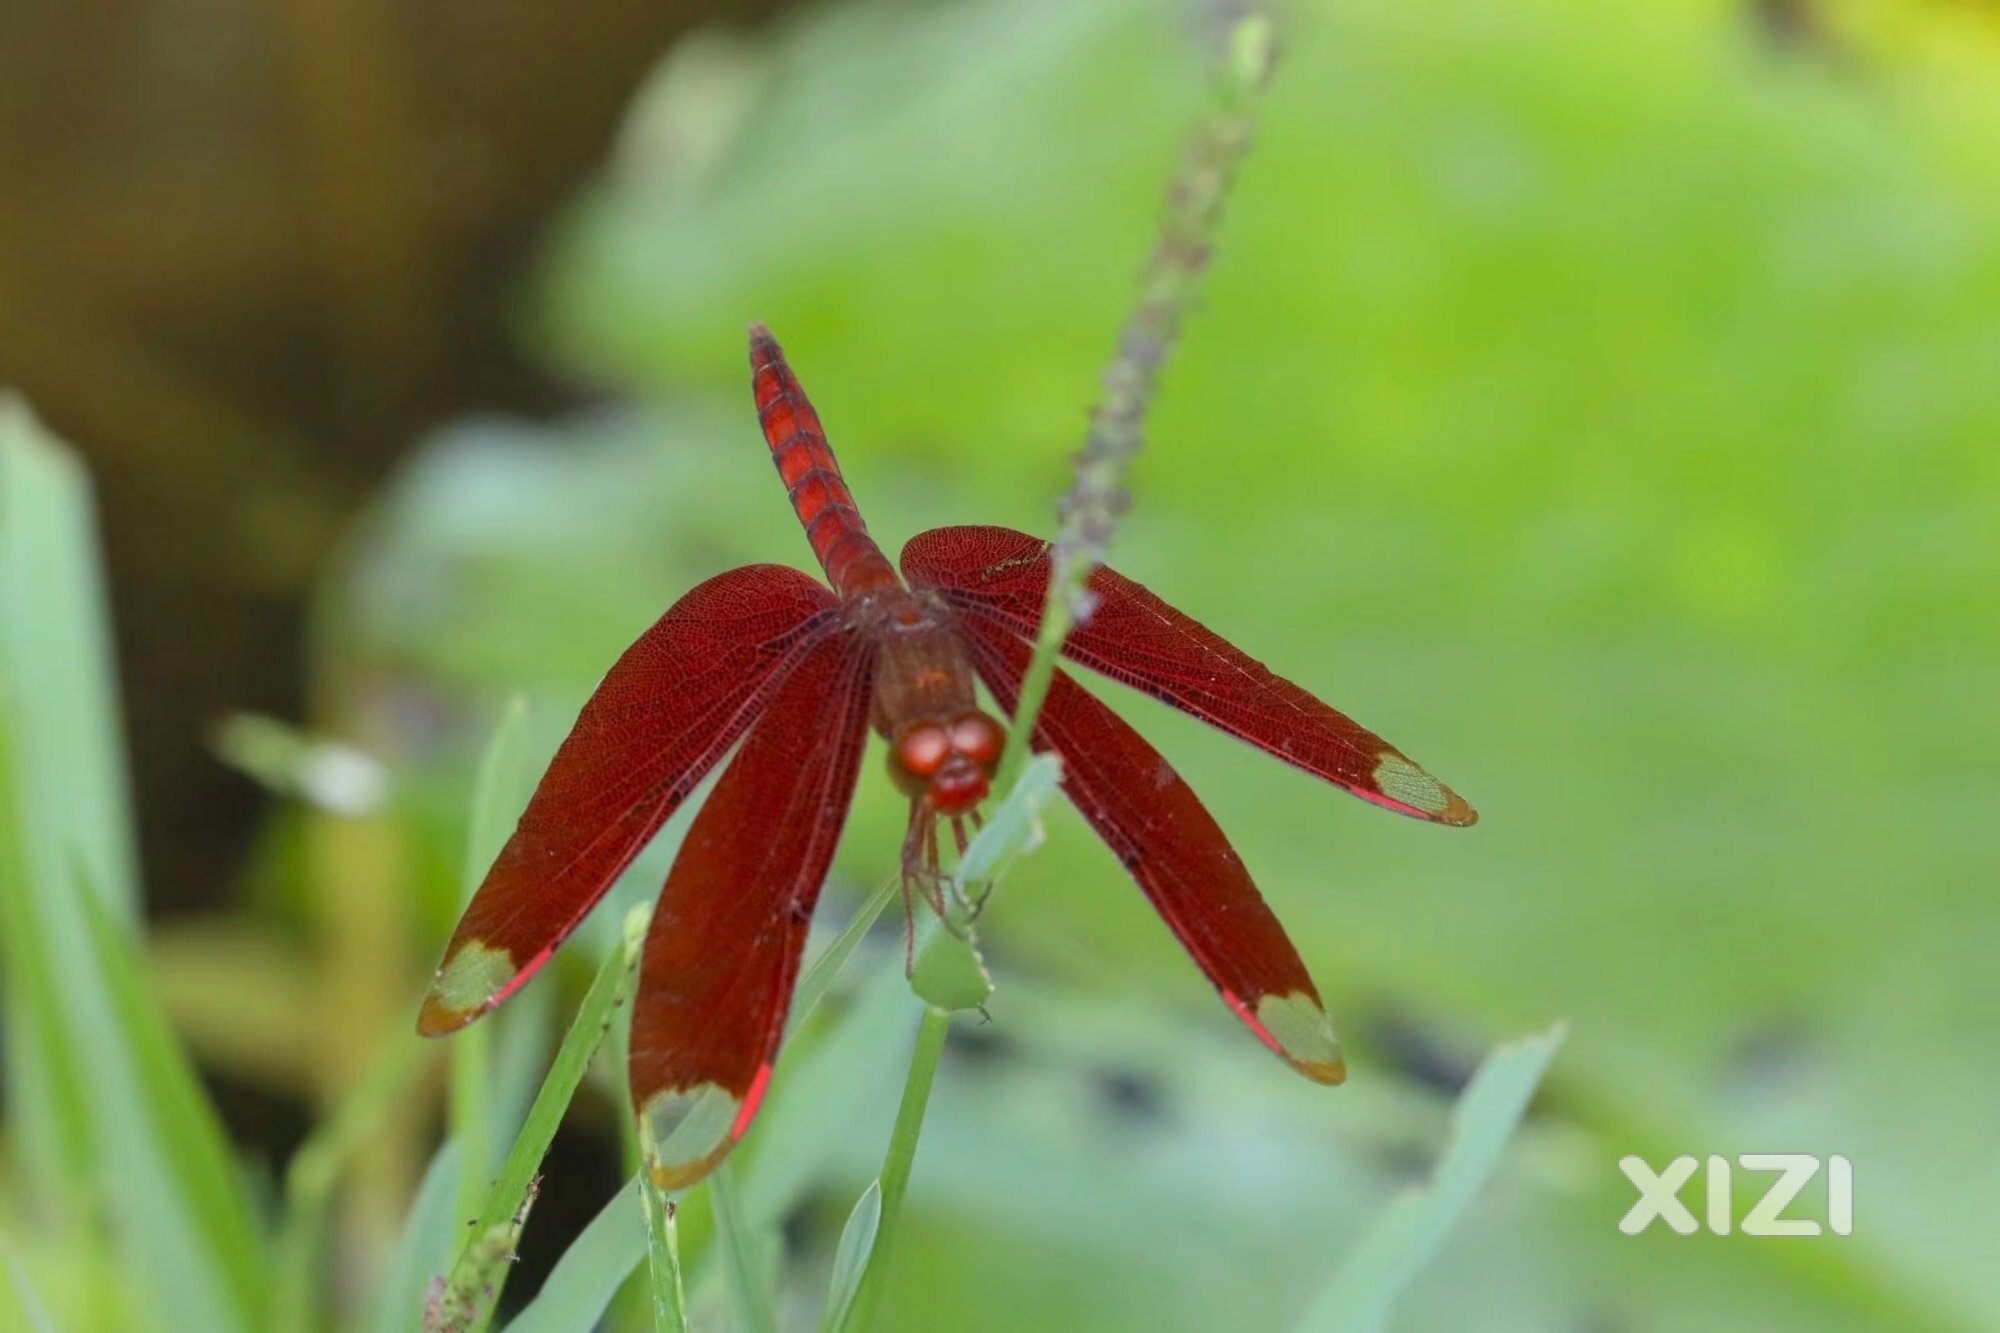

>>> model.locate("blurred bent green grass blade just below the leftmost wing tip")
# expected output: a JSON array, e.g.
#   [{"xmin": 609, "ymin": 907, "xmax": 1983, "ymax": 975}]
[{"xmin": 270, "ymin": 1029, "xmax": 428, "ymax": 1333}]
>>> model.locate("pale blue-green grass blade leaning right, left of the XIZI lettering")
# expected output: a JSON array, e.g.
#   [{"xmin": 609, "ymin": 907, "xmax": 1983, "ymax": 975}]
[{"xmin": 1298, "ymin": 1023, "xmax": 1564, "ymax": 1333}]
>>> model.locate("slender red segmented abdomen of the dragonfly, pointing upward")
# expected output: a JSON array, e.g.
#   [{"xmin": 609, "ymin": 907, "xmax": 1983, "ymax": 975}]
[{"xmin": 750, "ymin": 324, "xmax": 900, "ymax": 596}]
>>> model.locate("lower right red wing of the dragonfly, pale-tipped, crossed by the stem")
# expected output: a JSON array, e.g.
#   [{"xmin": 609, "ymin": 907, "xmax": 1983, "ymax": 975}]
[{"xmin": 960, "ymin": 614, "xmax": 1346, "ymax": 1083}]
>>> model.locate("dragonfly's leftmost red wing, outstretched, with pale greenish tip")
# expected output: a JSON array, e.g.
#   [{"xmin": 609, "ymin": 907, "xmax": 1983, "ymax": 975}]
[{"xmin": 416, "ymin": 564, "xmax": 840, "ymax": 1037}]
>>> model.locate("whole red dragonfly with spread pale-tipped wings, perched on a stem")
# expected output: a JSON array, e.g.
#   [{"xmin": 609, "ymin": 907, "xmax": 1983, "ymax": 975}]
[{"xmin": 418, "ymin": 324, "xmax": 1476, "ymax": 1189}]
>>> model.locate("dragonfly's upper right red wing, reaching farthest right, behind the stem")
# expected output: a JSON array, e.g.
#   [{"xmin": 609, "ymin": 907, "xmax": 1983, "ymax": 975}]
[{"xmin": 902, "ymin": 528, "xmax": 1478, "ymax": 825}]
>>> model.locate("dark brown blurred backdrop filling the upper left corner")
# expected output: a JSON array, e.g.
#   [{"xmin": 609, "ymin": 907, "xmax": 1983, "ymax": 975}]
[{"xmin": 0, "ymin": 0, "xmax": 784, "ymax": 911}]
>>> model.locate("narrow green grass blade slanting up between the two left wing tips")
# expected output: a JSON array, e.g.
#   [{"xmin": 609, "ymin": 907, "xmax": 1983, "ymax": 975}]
[{"xmin": 424, "ymin": 907, "xmax": 652, "ymax": 1333}]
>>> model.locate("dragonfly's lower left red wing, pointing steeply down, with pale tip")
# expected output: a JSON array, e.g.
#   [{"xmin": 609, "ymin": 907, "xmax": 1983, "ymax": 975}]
[{"xmin": 632, "ymin": 616, "xmax": 874, "ymax": 1189}]
